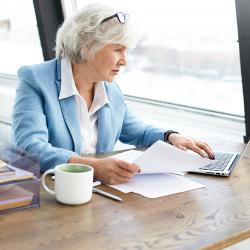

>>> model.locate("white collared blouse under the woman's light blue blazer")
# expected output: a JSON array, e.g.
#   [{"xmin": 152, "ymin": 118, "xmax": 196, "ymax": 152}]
[{"xmin": 59, "ymin": 59, "xmax": 109, "ymax": 154}]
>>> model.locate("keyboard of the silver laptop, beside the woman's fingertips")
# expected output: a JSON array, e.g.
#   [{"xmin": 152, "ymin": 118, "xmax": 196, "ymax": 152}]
[{"xmin": 200, "ymin": 152, "xmax": 233, "ymax": 171}]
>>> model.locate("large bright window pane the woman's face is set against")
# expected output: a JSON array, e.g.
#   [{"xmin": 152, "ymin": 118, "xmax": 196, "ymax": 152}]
[{"xmin": 77, "ymin": 0, "xmax": 244, "ymax": 115}]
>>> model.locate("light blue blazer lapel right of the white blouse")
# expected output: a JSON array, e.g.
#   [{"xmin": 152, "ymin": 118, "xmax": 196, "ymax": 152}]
[{"xmin": 96, "ymin": 104, "xmax": 112, "ymax": 153}]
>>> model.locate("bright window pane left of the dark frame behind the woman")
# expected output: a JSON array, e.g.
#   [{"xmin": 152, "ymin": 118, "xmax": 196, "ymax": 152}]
[{"xmin": 0, "ymin": 0, "xmax": 43, "ymax": 74}]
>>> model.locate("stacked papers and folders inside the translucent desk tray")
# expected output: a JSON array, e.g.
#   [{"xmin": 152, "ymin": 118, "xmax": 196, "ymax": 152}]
[{"xmin": 0, "ymin": 160, "xmax": 37, "ymax": 212}]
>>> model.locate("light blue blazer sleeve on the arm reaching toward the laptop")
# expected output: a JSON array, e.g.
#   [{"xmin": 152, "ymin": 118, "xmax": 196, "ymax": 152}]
[{"xmin": 119, "ymin": 104, "xmax": 166, "ymax": 147}]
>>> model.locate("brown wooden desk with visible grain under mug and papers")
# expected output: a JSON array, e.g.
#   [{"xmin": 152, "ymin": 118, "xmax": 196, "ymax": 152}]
[{"xmin": 0, "ymin": 142, "xmax": 250, "ymax": 250}]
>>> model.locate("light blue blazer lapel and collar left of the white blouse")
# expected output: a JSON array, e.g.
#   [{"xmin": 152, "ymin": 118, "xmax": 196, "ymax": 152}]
[{"xmin": 56, "ymin": 60, "xmax": 81, "ymax": 154}]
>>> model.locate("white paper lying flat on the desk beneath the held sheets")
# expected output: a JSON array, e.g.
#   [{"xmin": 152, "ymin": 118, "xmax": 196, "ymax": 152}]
[{"xmin": 110, "ymin": 174, "xmax": 205, "ymax": 198}]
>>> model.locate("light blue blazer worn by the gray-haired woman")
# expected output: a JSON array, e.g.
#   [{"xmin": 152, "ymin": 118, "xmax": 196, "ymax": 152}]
[{"xmin": 12, "ymin": 59, "xmax": 166, "ymax": 171}]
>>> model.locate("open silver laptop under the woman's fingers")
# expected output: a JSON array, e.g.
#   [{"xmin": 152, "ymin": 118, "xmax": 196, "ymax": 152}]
[{"xmin": 189, "ymin": 143, "xmax": 250, "ymax": 176}]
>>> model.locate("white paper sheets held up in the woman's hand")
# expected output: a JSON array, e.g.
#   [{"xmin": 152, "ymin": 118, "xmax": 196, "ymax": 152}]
[{"xmin": 112, "ymin": 141, "xmax": 213, "ymax": 174}]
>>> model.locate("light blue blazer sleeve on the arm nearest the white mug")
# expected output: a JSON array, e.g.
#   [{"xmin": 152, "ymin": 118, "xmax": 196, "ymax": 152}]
[{"xmin": 12, "ymin": 69, "xmax": 76, "ymax": 174}]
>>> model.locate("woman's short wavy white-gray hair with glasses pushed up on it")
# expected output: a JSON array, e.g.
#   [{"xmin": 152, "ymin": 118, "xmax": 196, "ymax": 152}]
[{"xmin": 55, "ymin": 4, "xmax": 137, "ymax": 63}]
